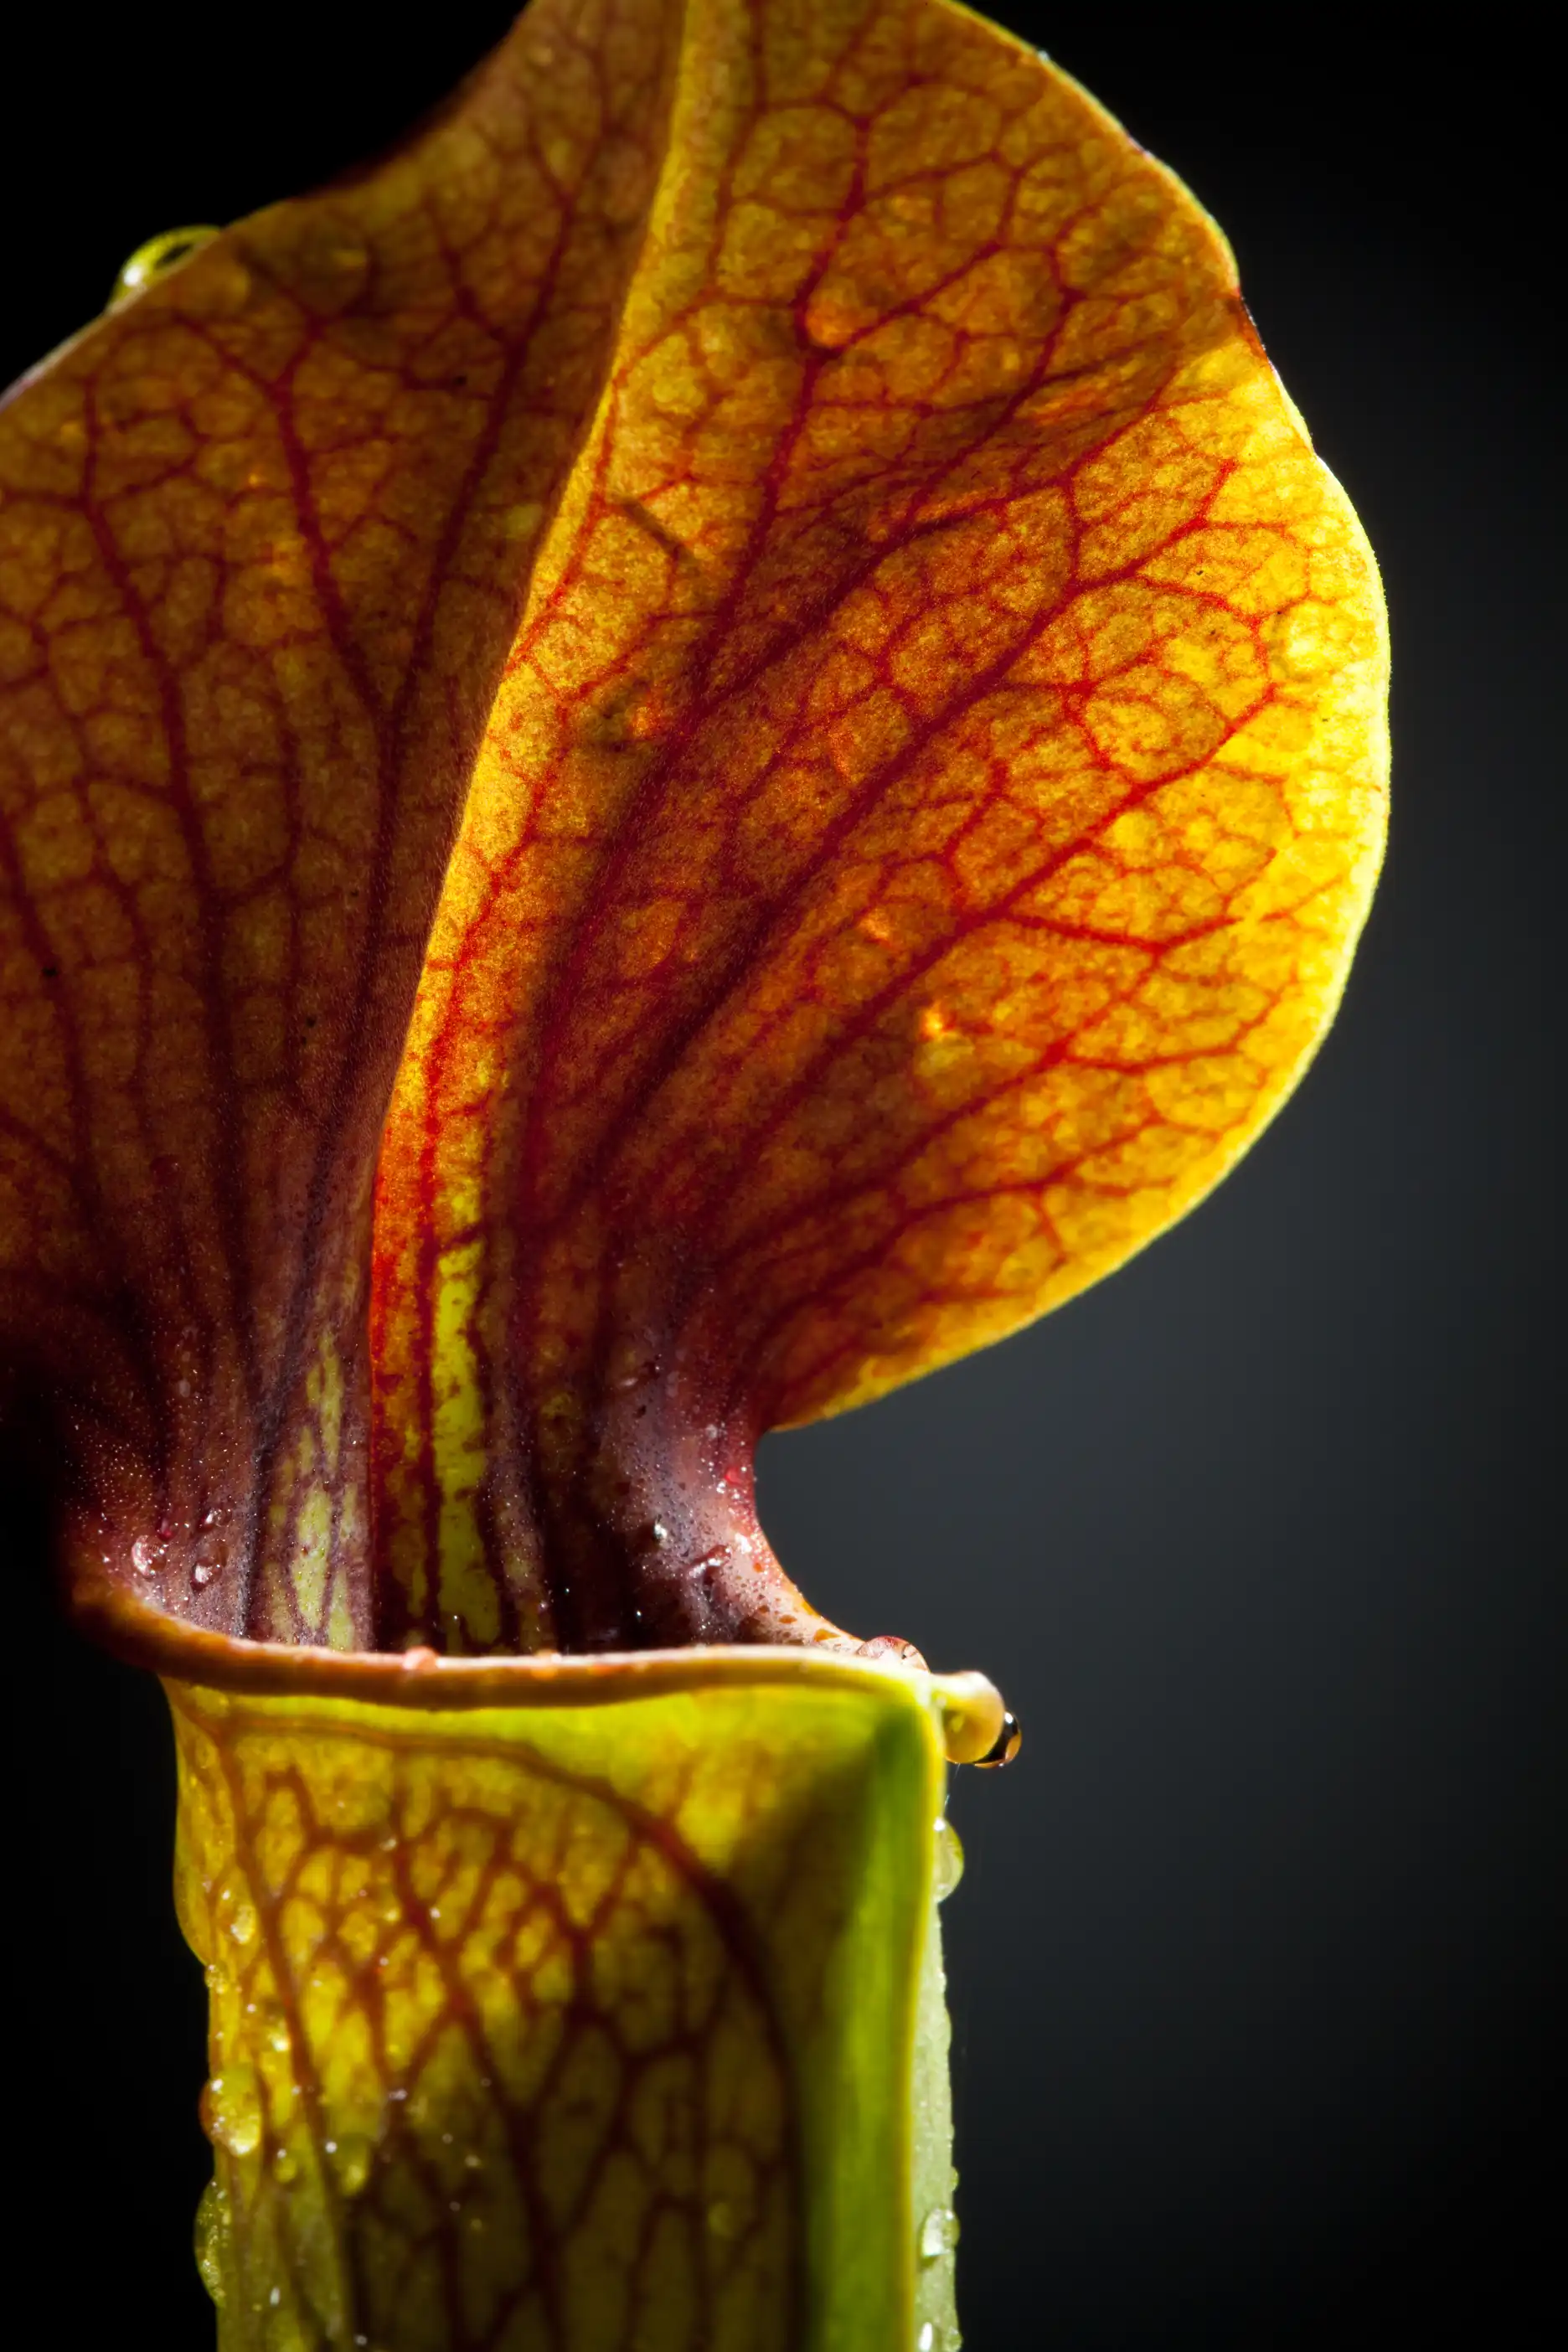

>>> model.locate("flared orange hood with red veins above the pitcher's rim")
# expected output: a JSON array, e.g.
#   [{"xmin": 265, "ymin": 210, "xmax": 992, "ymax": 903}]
[{"xmin": 0, "ymin": 0, "xmax": 1385, "ymax": 1651}]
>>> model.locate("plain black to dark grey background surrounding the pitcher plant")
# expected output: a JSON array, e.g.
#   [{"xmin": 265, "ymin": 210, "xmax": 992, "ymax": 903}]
[{"xmin": 0, "ymin": 0, "xmax": 1568, "ymax": 2352}]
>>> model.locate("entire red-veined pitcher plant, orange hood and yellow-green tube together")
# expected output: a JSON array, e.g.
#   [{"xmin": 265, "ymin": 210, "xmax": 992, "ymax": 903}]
[{"xmin": 0, "ymin": 0, "xmax": 1385, "ymax": 2352}]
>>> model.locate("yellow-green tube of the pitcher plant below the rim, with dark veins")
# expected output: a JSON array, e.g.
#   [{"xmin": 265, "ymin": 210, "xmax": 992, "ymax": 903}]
[{"xmin": 164, "ymin": 1651, "xmax": 957, "ymax": 2352}]
